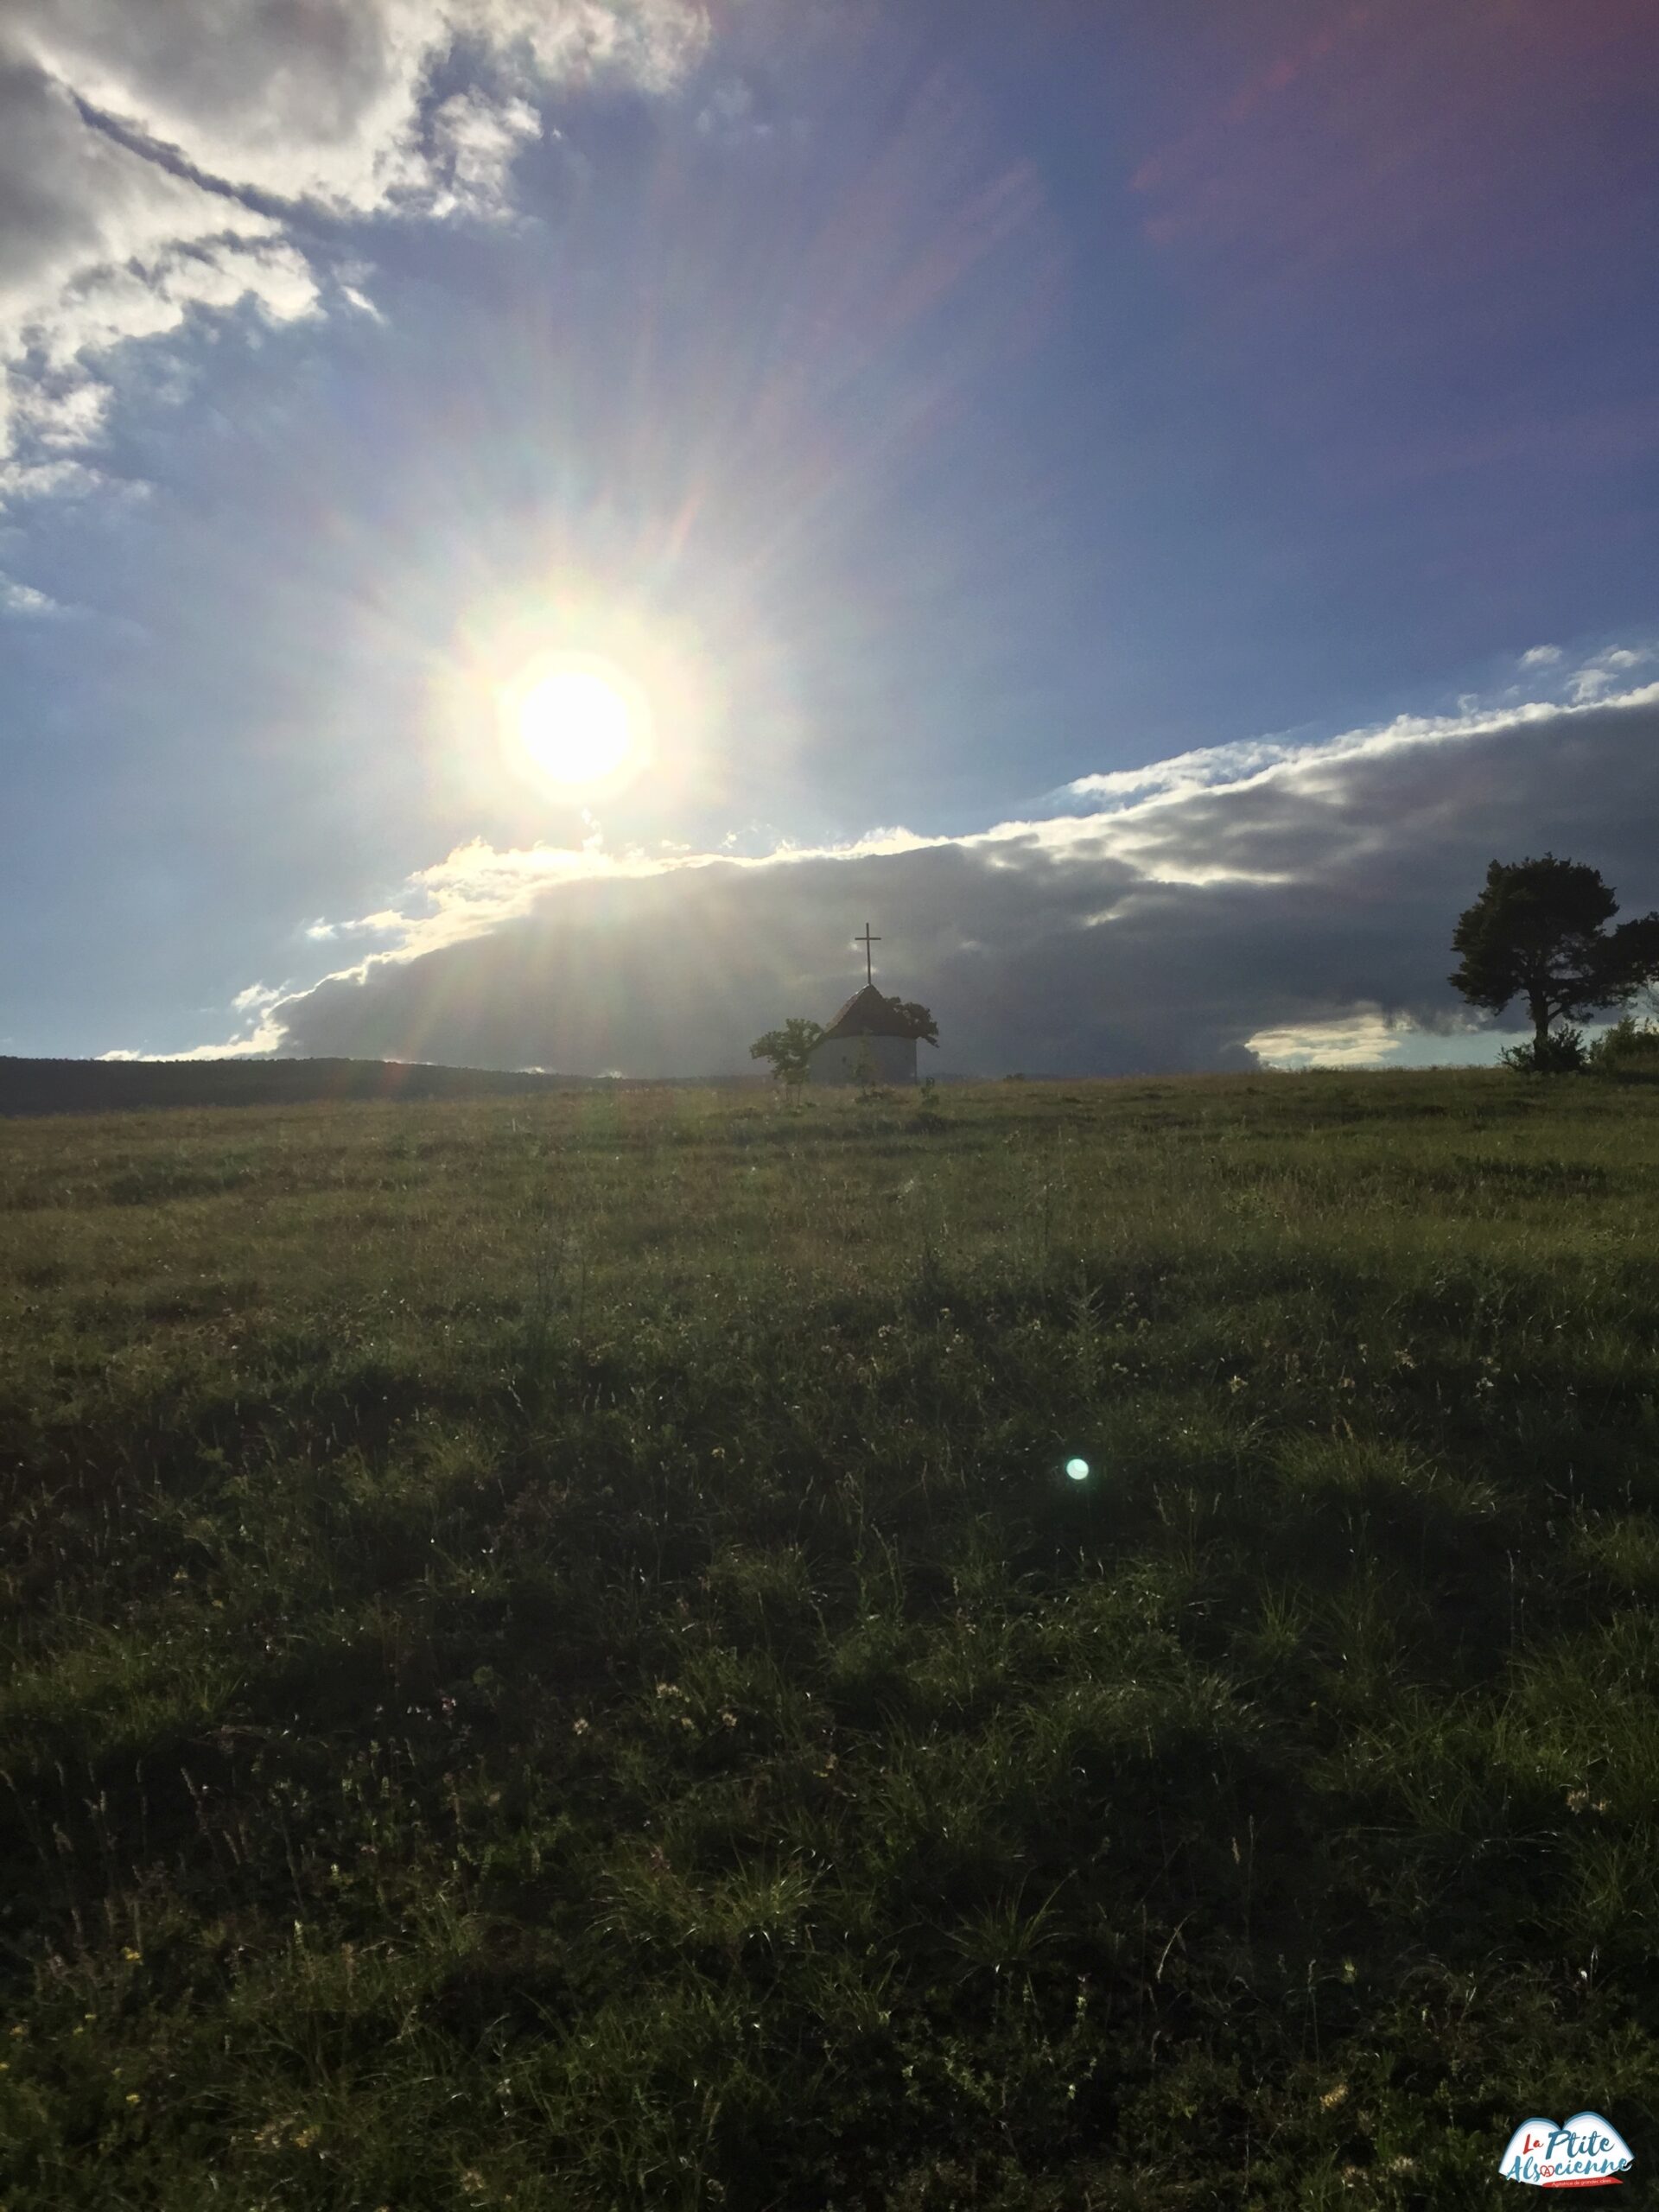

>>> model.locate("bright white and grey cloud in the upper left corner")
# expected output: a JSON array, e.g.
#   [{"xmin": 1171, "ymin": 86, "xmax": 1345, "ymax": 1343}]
[{"xmin": 0, "ymin": 0, "xmax": 708, "ymax": 475}]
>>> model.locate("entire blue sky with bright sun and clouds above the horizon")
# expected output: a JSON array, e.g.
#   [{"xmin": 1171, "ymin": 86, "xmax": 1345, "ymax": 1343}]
[{"xmin": 0, "ymin": 0, "xmax": 1659, "ymax": 1077}]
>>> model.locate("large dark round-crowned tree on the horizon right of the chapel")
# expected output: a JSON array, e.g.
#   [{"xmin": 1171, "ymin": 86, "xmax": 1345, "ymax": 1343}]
[{"xmin": 1446, "ymin": 854, "xmax": 1659, "ymax": 1068}]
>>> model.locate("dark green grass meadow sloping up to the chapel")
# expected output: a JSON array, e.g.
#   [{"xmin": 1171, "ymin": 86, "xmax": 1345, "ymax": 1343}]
[{"xmin": 0, "ymin": 1071, "xmax": 1659, "ymax": 2212}]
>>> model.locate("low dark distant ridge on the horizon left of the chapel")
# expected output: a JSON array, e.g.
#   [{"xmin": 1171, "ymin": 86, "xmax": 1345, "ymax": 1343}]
[{"xmin": 0, "ymin": 1055, "xmax": 767, "ymax": 1115}]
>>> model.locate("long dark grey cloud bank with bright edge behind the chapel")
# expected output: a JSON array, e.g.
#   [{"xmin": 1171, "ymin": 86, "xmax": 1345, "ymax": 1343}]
[{"xmin": 143, "ymin": 683, "xmax": 1659, "ymax": 1075}]
